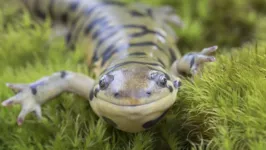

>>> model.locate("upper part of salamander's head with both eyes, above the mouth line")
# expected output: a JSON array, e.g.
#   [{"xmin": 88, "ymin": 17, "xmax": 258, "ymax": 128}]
[{"xmin": 94, "ymin": 64, "xmax": 180, "ymax": 106}]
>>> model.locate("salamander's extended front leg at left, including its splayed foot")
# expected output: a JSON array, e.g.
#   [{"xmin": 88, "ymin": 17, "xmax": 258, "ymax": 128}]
[{"xmin": 2, "ymin": 71, "xmax": 94, "ymax": 125}]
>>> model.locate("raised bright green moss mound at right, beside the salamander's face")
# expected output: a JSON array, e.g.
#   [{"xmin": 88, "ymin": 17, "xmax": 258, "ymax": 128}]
[{"xmin": 167, "ymin": 44, "xmax": 266, "ymax": 149}]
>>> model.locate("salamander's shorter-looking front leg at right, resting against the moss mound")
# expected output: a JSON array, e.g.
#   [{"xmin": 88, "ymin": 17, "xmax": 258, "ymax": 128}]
[{"xmin": 171, "ymin": 46, "xmax": 218, "ymax": 77}]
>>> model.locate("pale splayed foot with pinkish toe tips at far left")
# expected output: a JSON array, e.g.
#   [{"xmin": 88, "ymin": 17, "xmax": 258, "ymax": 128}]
[{"xmin": 2, "ymin": 83, "xmax": 42, "ymax": 125}]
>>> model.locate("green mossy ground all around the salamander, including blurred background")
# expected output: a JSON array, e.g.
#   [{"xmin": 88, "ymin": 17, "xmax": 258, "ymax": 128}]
[{"xmin": 0, "ymin": 0, "xmax": 266, "ymax": 150}]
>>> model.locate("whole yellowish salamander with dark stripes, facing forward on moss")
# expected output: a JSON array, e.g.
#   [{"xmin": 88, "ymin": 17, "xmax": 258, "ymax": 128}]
[{"xmin": 2, "ymin": 0, "xmax": 218, "ymax": 133}]
